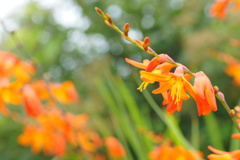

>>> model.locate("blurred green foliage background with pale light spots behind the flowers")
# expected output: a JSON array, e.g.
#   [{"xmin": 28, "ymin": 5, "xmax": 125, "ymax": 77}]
[{"xmin": 0, "ymin": 0, "xmax": 240, "ymax": 160}]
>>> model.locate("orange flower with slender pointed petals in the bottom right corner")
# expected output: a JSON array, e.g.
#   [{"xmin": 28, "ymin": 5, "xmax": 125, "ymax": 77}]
[{"xmin": 208, "ymin": 146, "xmax": 240, "ymax": 160}]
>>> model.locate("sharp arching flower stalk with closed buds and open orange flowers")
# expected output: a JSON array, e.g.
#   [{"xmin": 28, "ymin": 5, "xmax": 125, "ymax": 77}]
[{"xmin": 95, "ymin": 7, "xmax": 240, "ymax": 132}]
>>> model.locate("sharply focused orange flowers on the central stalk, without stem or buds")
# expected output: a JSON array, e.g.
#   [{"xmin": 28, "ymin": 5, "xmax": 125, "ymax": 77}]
[{"xmin": 125, "ymin": 54, "xmax": 217, "ymax": 116}]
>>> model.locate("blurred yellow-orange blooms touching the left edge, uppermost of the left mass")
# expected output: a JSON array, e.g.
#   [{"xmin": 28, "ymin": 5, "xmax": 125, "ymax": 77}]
[{"xmin": 0, "ymin": 51, "xmax": 35, "ymax": 115}]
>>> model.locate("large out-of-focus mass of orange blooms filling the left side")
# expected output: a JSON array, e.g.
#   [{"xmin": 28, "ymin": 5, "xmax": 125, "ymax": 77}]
[{"xmin": 0, "ymin": 52, "xmax": 125, "ymax": 160}]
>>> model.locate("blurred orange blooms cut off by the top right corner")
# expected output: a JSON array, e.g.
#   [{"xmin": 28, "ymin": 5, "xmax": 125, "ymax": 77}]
[{"xmin": 210, "ymin": 0, "xmax": 240, "ymax": 20}]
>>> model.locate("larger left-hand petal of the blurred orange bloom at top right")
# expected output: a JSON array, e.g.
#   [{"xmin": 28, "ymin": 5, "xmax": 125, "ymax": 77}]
[{"xmin": 210, "ymin": 0, "xmax": 229, "ymax": 19}]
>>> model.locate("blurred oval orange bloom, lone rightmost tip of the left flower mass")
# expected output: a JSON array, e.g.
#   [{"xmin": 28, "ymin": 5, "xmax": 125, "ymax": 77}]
[{"xmin": 105, "ymin": 137, "xmax": 125, "ymax": 158}]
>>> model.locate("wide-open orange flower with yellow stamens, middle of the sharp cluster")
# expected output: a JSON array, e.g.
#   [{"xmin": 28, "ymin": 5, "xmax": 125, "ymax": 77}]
[{"xmin": 140, "ymin": 66, "xmax": 195, "ymax": 114}]
